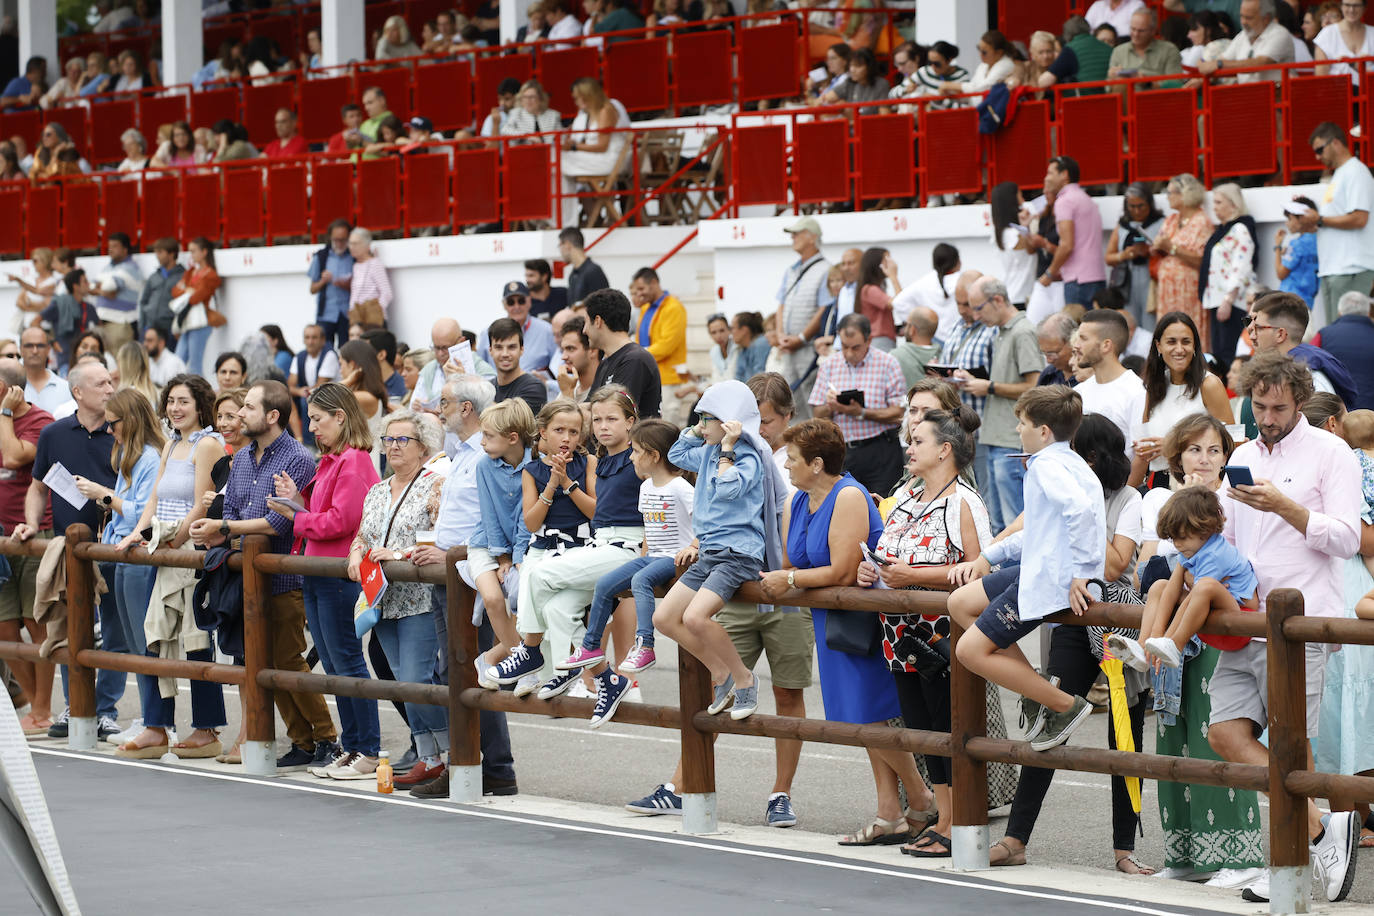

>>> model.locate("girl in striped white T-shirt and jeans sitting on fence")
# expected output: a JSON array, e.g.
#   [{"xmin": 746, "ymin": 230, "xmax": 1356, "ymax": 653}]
[{"xmin": 555, "ymin": 419, "xmax": 697, "ymax": 728}]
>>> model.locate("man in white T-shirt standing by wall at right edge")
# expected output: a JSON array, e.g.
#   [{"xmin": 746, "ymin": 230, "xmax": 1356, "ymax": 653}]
[{"xmin": 1303, "ymin": 121, "xmax": 1374, "ymax": 324}]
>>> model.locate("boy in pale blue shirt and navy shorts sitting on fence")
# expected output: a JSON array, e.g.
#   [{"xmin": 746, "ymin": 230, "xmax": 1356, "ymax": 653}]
[{"xmin": 949, "ymin": 385, "xmax": 1107, "ymax": 751}]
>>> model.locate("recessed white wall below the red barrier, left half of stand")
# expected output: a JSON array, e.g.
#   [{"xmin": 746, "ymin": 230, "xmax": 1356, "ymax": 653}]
[{"xmin": 0, "ymin": 227, "xmax": 710, "ymax": 353}]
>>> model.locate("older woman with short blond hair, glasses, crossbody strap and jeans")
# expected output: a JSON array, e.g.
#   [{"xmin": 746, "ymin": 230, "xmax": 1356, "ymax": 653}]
[{"xmin": 348, "ymin": 411, "xmax": 448, "ymax": 786}]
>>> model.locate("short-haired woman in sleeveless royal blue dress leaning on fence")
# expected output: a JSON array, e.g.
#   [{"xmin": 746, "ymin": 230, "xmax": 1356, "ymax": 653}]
[{"xmin": 764, "ymin": 420, "xmax": 936, "ymax": 846}]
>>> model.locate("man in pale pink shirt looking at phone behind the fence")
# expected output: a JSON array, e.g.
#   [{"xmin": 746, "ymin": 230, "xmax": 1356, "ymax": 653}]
[{"xmin": 1208, "ymin": 350, "xmax": 1363, "ymax": 901}]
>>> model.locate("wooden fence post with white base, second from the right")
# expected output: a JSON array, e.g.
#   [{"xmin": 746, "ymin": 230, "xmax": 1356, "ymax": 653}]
[{"xmin": 949, "ymin": 618, "xmax": 989, "ymax": 871}]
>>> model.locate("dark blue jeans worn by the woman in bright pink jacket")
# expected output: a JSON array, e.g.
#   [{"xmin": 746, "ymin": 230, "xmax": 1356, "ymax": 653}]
[{"xmin": 302, "ymin": 575, "xmax": 382, "ymax": 757}]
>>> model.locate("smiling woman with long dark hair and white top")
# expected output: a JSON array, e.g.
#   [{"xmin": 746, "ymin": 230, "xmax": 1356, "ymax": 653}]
[{"xmin": 1131, "ymin": 312, "xmax": 1235, "ymax": 489}]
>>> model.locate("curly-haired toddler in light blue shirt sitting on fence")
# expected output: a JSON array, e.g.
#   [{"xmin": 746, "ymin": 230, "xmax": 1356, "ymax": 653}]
[{"xmin": 1107, "ymin": 486, "xmax": 1260, "ymax": 672}]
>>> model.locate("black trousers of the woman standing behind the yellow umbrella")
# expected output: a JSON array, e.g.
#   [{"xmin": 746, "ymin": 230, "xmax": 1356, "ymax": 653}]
[{"xmin": 1005, "ymin": 626, "xmax": 1145, "ymax": 850}]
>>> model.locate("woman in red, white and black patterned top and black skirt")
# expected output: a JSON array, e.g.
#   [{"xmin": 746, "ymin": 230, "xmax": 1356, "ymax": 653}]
[{"xmin": 859, "ymin": 405, "xmax": 992, "ymax": 858}]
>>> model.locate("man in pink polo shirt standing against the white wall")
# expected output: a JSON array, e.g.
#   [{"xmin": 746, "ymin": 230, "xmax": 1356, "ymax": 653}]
[{"xmin": 1040, "ymin": 155, "xmax": 1107, "ymax": 310}]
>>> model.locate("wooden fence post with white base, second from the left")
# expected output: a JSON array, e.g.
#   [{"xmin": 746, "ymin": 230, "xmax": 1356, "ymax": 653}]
[{"xmin": 239, "ymin": 534, "xmax": 276, "ymax": 776}]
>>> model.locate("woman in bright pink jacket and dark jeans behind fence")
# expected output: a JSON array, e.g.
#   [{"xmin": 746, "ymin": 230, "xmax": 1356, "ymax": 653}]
[{"xmin": 276, "ymin": 382, "xmax": 382, "ymax": 779}]
